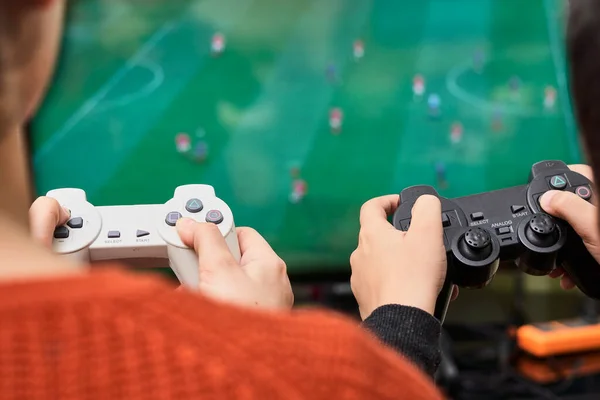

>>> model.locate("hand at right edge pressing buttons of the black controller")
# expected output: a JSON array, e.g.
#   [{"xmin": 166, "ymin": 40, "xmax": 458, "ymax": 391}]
[{"xmin": 540, "ymin": 165, "xmax": 600, "ymax": 290}]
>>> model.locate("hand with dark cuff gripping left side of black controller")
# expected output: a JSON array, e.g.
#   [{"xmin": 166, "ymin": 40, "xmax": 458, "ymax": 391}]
[{"xmin": 350, "ymin": 195, "xmax": 457, "ymax": 320}]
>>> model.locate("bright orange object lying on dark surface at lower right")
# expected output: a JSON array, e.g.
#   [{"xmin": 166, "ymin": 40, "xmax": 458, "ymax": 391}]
[{"xmin": 517, "ymin": 319, "xmax": 600, "ymax": 357}]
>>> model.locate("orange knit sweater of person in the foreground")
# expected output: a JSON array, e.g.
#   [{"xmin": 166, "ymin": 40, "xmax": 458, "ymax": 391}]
[{"xmin": 0, "ymin": 269, "xmax": 441, "ymax": 400}]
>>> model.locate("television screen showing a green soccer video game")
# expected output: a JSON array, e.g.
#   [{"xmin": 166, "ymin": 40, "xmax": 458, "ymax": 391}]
[{"xmin": 32, "ymin": 0, "xmax": 581, "ymax": 273}]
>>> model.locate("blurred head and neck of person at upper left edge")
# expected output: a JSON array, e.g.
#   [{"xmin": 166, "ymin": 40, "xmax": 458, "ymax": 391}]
[{"xmin": 0, "ymin": 0, "xmax": 64, "ymax": 221}]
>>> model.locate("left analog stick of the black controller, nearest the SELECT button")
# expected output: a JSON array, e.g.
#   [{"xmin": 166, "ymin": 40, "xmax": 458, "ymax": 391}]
[{"xmin": 452, "ymin": 228, "xmax": 500, "ymax": 288}]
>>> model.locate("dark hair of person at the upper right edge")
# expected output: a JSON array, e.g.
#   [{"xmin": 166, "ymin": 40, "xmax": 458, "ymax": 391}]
[{"xmin": 567, "ymin": 0, "xmax": 600, "ymax": 177}]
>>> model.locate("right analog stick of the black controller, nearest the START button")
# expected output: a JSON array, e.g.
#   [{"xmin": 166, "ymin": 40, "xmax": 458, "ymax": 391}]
[{"xmin": 517, "ymin": 214, "xmax": 565, "ymax": 276}]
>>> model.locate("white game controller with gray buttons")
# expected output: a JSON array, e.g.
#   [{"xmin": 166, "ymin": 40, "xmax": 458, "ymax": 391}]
[{"xmin": 47, "ymin": 185, "xmax": 241, "ymax": 289}]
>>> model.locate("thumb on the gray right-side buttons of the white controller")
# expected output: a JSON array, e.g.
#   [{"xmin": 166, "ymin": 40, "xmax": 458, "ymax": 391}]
[{"xmin": 177, "ymin": 218, "xmax": 238, "ymax": 271}]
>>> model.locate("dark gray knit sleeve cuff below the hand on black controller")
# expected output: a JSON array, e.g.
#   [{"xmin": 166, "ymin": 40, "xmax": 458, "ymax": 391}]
[{"xmin": 363, "ymin": 304, "xmax": 442, "ymax": 378}]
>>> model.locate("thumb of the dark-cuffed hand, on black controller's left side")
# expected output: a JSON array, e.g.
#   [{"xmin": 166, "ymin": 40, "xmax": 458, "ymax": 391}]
[{"xmin": 407, "ymin": 195, "xmax": 443, "ymax": 238}]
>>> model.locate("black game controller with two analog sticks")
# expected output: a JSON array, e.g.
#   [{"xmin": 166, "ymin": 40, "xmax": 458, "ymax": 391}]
[{"xmin": 393, "ymin": 161, "xmax": 600, "ymax": 322}]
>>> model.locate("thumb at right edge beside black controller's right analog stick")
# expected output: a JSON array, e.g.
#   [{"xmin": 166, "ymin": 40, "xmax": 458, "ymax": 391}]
[{"xmin": 540, "ymin": 190, "xmax": 598, "ymax": 246}]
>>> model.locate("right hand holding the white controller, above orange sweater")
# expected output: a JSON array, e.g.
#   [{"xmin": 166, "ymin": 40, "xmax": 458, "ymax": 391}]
[{"xmin": 177, "ymin": 218, "xmax": 294, "ymax": 309}]
